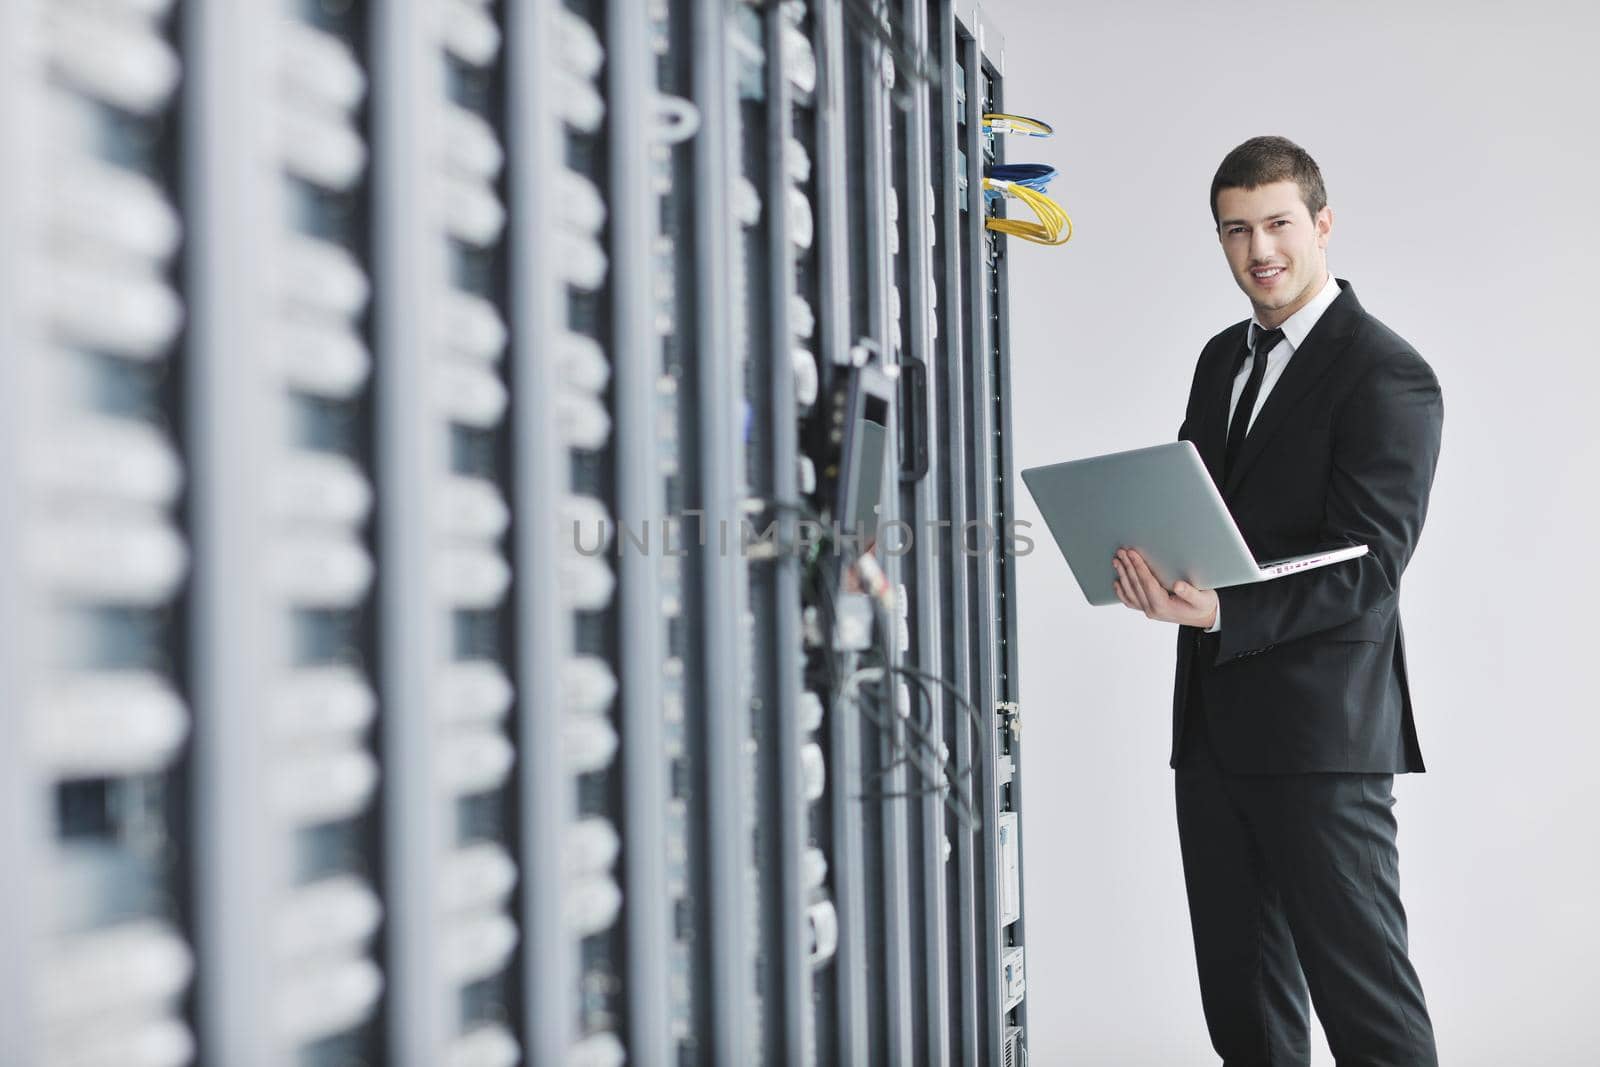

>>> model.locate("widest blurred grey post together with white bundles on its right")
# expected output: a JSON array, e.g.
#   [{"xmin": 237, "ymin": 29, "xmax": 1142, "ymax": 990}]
[{"xmin": 184, "ymin": 0, "xmax": 387, "ymax": 1064}]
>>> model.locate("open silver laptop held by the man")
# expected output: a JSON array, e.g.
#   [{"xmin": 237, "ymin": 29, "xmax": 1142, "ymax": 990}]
[{"xmin": 1022, "ymin": 442, "xmax": 1366, "ymax": 605}]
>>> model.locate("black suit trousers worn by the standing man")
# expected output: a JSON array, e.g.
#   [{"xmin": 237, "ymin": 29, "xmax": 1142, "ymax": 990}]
[{"xmin": 1176, "ymin": 646, "xmax": 1438, "ymax": 1067}]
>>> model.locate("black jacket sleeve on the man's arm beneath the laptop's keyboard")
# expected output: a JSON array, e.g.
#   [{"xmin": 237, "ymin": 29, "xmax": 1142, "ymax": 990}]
[{"xmin": 1218, "ymin": 352, "xmax": 1445, "ymax": 662}]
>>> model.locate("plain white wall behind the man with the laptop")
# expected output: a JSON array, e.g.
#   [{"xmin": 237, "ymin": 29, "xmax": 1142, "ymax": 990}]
[{"xmin": 986, "ymin": 0, "xmax": 1600, "ymax": 1067}]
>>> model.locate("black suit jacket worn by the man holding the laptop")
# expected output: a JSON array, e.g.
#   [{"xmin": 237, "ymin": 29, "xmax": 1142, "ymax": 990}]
[{"xmin": 1173, "ymin": 278, "xmax": 1445, "ymax": 773}]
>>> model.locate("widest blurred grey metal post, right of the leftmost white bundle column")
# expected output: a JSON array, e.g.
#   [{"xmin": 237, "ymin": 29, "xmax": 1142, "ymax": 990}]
[{"xmin": 186, "ymin": 0, "xmax": 285, "ymax": 1067}]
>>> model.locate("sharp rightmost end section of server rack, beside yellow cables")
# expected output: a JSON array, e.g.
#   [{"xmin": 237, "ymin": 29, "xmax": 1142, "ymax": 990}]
[{"xmin": 926, "ymin": 0, "xmax": 1026, "ymax": 1062}]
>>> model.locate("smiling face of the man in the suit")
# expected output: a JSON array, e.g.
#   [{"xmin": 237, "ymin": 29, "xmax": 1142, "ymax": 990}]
[{"xmin": 1216, "ymin": 181, "xmax": 1333, "ymax": 330}]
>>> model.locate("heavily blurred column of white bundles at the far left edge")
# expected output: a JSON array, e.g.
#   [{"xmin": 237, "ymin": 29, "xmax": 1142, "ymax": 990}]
[{"xmin": 0, "ymin": 3, "xmax": 195, "ymax": 1065}]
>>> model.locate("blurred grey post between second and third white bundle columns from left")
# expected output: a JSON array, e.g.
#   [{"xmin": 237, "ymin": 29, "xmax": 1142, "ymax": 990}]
[{"xmin": 373, "ymin": 0, "xmax": 451, "ymax": 1067}]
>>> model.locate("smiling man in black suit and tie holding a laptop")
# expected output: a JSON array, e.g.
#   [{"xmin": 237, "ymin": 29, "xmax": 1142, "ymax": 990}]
[{"xmin": 1112, "ymin": 138, "xmax": 1443, "ymax": 1067}]
